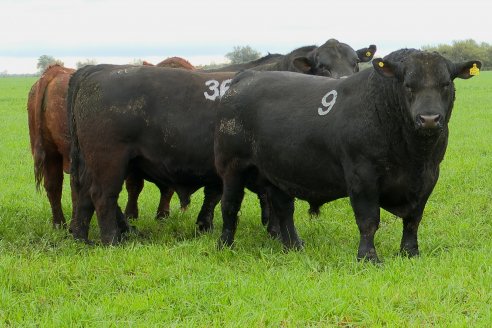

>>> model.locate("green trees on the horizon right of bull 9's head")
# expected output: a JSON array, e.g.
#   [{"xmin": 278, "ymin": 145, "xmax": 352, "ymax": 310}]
[{"xmin": 422, "ymin": 39, "xmax": 492, "ymax": 70}]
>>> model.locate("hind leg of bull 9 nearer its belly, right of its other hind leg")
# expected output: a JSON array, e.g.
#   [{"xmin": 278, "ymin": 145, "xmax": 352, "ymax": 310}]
[{"xmin": 267, "ymin": 186, "xmax": 303, "ymax": 249}]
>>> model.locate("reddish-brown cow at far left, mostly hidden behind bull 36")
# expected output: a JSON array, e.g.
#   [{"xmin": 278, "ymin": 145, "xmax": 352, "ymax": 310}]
[{"xmin": 27, "ymin": 65, "xmax": 180, "ymax": 228}]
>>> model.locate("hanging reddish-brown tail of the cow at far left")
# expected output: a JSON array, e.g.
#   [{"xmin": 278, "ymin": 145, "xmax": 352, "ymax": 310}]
[{"xmin": 27, "ymin": 66, "xmax": 58, "ymax": 191}]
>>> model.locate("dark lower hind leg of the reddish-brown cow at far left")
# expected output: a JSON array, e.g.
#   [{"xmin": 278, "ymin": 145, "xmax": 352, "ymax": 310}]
[{"xmin": 43, "ymin": 154, "xmax": 66, "ymax": 228}]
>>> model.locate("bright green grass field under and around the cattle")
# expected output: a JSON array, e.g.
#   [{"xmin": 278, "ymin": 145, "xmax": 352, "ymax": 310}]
[{"xmin": 0, "ymin": 72, "xmax": 492, "ymax": 327}]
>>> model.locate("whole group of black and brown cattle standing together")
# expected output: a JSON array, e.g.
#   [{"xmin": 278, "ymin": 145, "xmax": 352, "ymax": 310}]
[{"xmin": 28, "ymin": 39, "xmax": 481, "ymax": 261}]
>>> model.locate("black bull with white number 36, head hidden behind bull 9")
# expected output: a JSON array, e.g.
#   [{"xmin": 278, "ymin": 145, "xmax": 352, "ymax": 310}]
[{"xmin": 67, "ymin": 65, "xmax": 234, "ymax": 244}]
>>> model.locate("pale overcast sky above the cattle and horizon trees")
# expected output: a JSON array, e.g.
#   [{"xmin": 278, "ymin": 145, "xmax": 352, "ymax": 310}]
[{"xmin": 0, "ymin": 0, "xmax": 492, "ymax": 73}]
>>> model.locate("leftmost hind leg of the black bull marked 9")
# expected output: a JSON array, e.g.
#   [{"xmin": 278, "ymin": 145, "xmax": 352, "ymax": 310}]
[{"xmin": 219, "ymin": 172, "xmax": 245, "ymax": 247}]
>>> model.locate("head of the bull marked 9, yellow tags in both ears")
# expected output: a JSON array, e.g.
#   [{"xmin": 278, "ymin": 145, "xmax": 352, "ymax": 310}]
[{"xmin": 372, "ymin": 51, "xmax": 482, "ymax": 133}]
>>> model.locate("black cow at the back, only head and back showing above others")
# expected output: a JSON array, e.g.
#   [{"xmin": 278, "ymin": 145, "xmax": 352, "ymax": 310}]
[{"xmin": 206, "ymin": 39, "xmax": 376, "ymax": 78}]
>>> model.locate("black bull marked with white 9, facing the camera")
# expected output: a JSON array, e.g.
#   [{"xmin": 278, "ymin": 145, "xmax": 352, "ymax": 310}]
[{"xmin": 215, "ymin": 49, "xmax": 481, "ymax": 261}]
